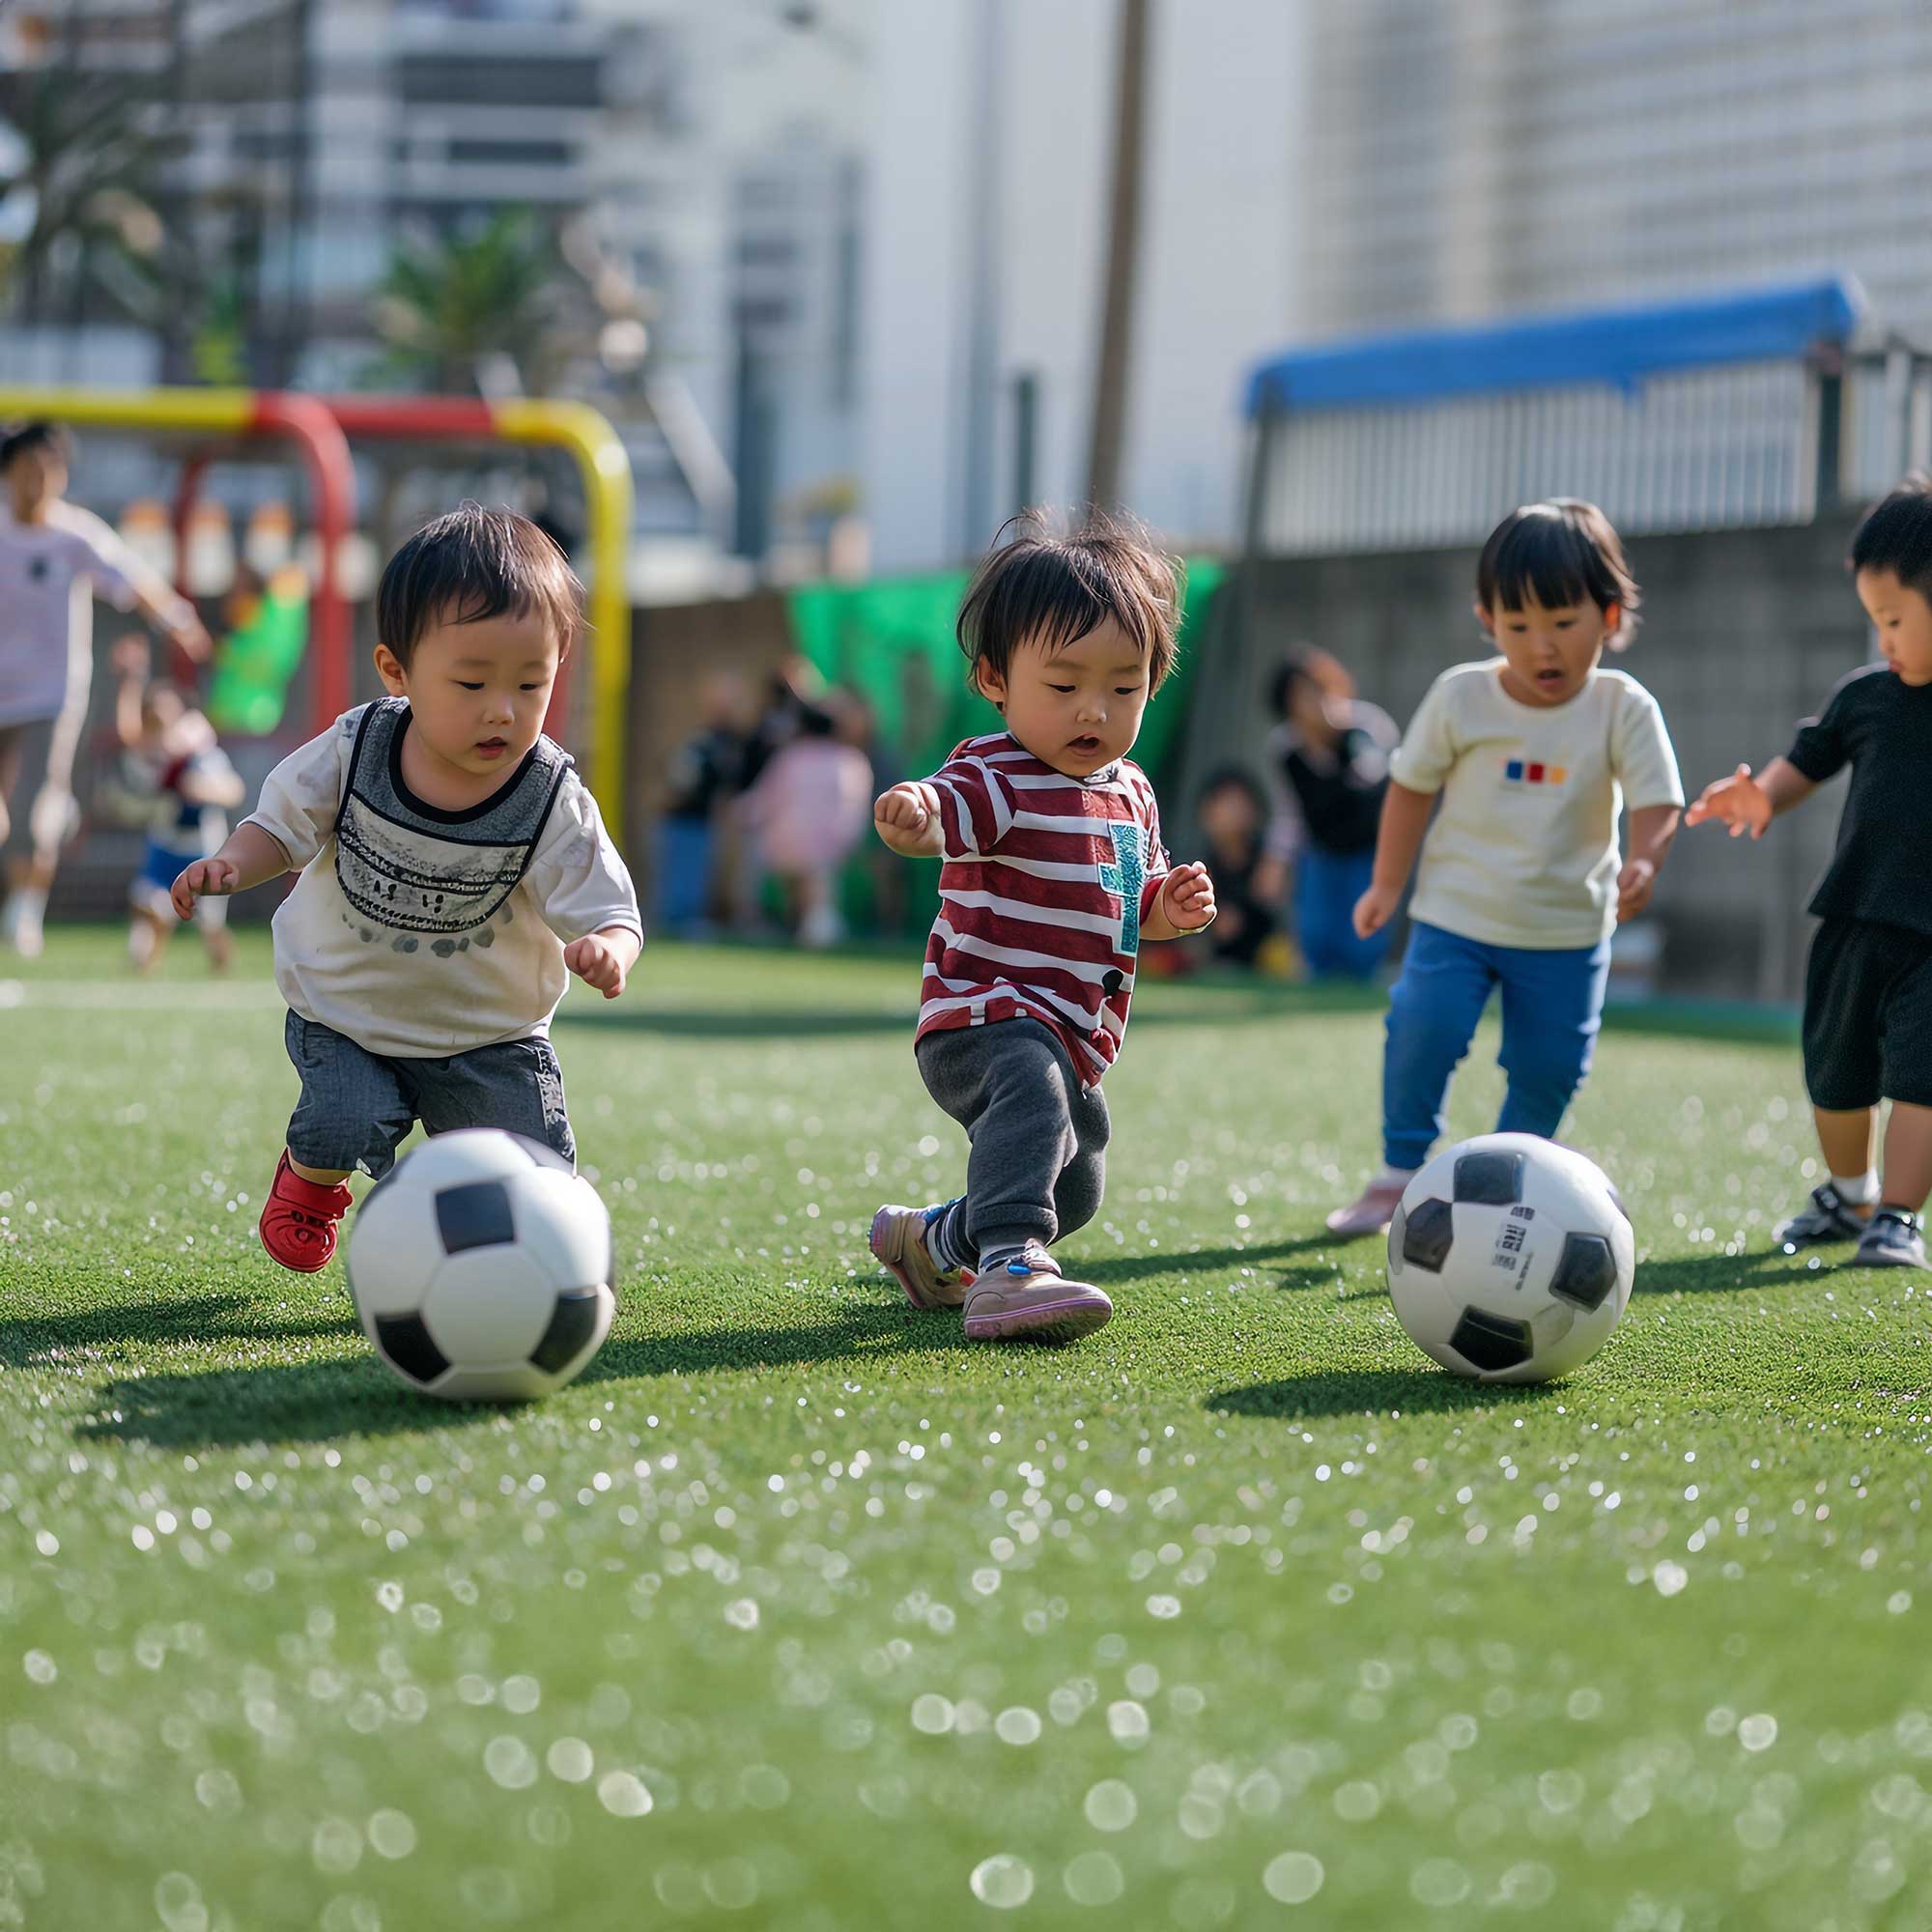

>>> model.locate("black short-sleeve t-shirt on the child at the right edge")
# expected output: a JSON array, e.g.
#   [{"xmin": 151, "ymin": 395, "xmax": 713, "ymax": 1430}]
[{"xmin": 1785, "ymin": 665, "xmax": 1932, "ymax": 933}]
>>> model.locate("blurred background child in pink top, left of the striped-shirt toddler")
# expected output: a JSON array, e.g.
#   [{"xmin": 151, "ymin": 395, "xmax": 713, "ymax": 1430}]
[{"xmin": 744, "ymin": 692, "xmax": 873, "ymax": 947}]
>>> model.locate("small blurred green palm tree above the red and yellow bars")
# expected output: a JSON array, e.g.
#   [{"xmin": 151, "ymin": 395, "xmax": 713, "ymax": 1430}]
[{"xmin": 371, "ymin": 209, "xmax": 570, "ymax": 392}]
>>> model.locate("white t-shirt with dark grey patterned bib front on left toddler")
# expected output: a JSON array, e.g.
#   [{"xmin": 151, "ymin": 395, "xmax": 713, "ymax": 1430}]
[{"xmin": 243, "ymin": 699, "xmax": 643, "ymax": 1059}]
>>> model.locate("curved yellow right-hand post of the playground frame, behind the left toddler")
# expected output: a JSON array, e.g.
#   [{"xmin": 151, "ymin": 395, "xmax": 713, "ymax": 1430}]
[{"xmin": 491, "ymin": 400, "xmax": 630, "ymax": 838}]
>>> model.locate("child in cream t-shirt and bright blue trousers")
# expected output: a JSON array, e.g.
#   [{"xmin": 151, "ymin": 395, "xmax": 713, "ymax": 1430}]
[{"xmin": 1327, "ymin": 498, "xmax": 1683, "ymax": 1235}]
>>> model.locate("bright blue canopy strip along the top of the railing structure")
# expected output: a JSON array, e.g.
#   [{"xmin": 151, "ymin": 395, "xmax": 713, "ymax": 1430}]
[{"xmin": 1248, "ymin": 276, "xmax": 1864, "ymax": 417}]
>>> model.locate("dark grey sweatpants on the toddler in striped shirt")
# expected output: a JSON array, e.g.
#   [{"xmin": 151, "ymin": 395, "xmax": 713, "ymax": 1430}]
[{"xmin": 914, "ymin": 1020, "xmax": 1109, "ymax": 1267}]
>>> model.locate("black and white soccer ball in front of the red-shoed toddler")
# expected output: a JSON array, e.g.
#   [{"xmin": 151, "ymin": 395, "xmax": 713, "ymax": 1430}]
[{"xmin": 348, "ymin": 1128, "xmax": 616, "ymax": 1403}]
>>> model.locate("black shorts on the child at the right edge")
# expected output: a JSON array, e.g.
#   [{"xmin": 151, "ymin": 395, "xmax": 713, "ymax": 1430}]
[{"xmin": 1804, "ymin": 920, "xmax": 1932, "ymax": 1113}]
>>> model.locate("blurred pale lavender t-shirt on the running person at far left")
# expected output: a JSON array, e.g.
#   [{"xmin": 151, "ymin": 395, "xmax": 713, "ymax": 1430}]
[{"xmin": 0, "ymin": 502, "xmax": 149, "ymax": 726}]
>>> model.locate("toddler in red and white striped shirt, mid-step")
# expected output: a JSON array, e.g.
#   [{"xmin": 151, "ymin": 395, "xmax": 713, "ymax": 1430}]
[{"xmin": 871, "ymin": 524, "xmax": 1215, "ymax": 1341}]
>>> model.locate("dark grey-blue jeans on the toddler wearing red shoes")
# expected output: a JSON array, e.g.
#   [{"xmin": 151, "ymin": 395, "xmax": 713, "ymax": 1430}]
[{"xmin": 284, "ymin": 1012, "xmax": 578, "ymax": 1180}]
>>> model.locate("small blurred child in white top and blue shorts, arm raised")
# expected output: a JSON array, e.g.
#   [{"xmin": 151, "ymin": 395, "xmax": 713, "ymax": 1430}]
[{"xmin": 114, "ymin": 636, "xmax": 245, "ymax": 972}]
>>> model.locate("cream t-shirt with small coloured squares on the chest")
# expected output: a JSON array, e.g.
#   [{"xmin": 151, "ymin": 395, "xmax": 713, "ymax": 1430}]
[{"xmin": 1389, "ymin": 657, "xmax": 1685, "ymax": 951}]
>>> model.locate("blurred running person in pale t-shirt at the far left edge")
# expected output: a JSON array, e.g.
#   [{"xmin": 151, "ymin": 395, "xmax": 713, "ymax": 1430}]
[{"xmin": 0, "ymin": 423, "xmax": 211, "ymax": 958}]
